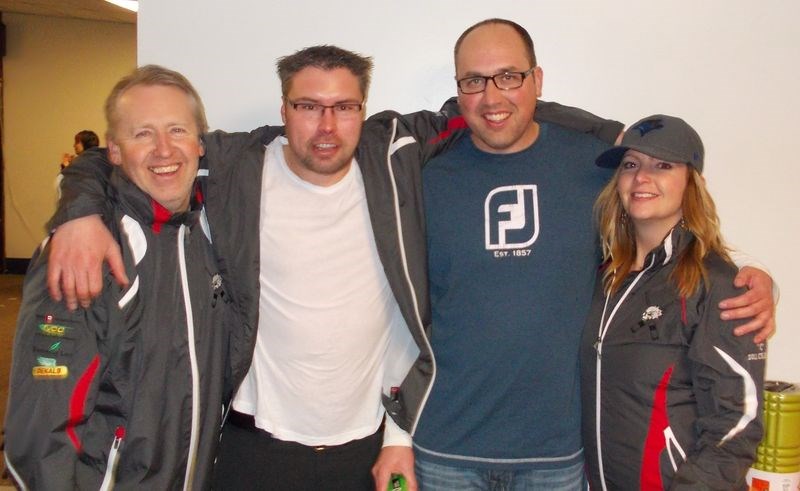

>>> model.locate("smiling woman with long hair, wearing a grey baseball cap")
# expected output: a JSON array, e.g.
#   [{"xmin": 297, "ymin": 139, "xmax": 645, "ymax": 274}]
[{"xmin": 581, "ymin": 114, "xmax": 766, "ymax": 490}]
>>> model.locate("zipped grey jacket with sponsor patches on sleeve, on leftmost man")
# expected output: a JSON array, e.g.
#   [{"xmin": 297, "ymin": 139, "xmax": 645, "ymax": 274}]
[{"xmin": 5, "ymin": 166, "xmax": 230, "ymax": 491}]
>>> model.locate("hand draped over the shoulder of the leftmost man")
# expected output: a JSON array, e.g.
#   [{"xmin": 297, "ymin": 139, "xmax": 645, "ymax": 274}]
[{"xmin": 47, "ymin": 215, "xmax": 128, "ymax": 310}]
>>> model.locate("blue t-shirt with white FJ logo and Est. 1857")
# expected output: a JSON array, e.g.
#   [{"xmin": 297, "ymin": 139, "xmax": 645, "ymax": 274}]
[{"xmin": 414, "ymin": 123, "xmax": 611, "ymax": 468}]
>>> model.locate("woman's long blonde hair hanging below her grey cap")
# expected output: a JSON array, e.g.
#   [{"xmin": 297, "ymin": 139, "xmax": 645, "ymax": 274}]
[{"xmin": 594, "ymin": 166, "xmax": 731, "ymax": 297}]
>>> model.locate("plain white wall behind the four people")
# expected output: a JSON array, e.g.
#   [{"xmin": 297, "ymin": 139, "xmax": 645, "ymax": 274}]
[{"xmin": 139, "ymin": 0, "xmax": 800, "ymax": 382}]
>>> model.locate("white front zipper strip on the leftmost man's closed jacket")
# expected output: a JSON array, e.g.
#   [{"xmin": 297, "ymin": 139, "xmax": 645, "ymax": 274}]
[{"xmin": 178, "ymin": 225, "xmax": 200, "ymax": 490}]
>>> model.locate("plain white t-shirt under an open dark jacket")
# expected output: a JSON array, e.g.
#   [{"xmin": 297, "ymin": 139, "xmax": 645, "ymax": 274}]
[{"xmin": 233, "ymin": 138, "xmax": 405, "ymax": 445}]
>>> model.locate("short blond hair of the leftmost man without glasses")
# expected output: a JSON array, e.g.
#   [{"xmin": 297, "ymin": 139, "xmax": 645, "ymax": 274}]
[{"xmin": 105, "ymin": 65, "xmax": 208, "ymax": 138}]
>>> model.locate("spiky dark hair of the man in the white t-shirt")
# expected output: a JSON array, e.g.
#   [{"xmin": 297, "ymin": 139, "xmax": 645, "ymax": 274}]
[{"xmin": 276, "ymin": 44, "xmax": 372, "ymax": 99}]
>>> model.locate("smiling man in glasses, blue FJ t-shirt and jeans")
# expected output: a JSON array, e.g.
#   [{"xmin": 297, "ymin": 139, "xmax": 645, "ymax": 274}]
[{"xmin": 414, "ymin": 19, "xmax": 772, "ymax": 490}]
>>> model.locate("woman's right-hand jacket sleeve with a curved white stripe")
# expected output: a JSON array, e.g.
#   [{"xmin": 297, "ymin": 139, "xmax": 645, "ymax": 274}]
[{"xmin": 671, "ymin": 268, "xmax": 766, "ymax": 490}]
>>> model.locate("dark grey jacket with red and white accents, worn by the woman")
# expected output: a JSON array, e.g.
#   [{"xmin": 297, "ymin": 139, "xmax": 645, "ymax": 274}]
[{"xmin": 581, "ymin": 227, "xmax": 766, "ymax": 491}]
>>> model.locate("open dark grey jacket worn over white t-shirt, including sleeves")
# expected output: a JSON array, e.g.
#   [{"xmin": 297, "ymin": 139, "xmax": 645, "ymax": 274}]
[{"xmin": 45, "ymin": 99, "xmax": 622, "ymax": 440}]
